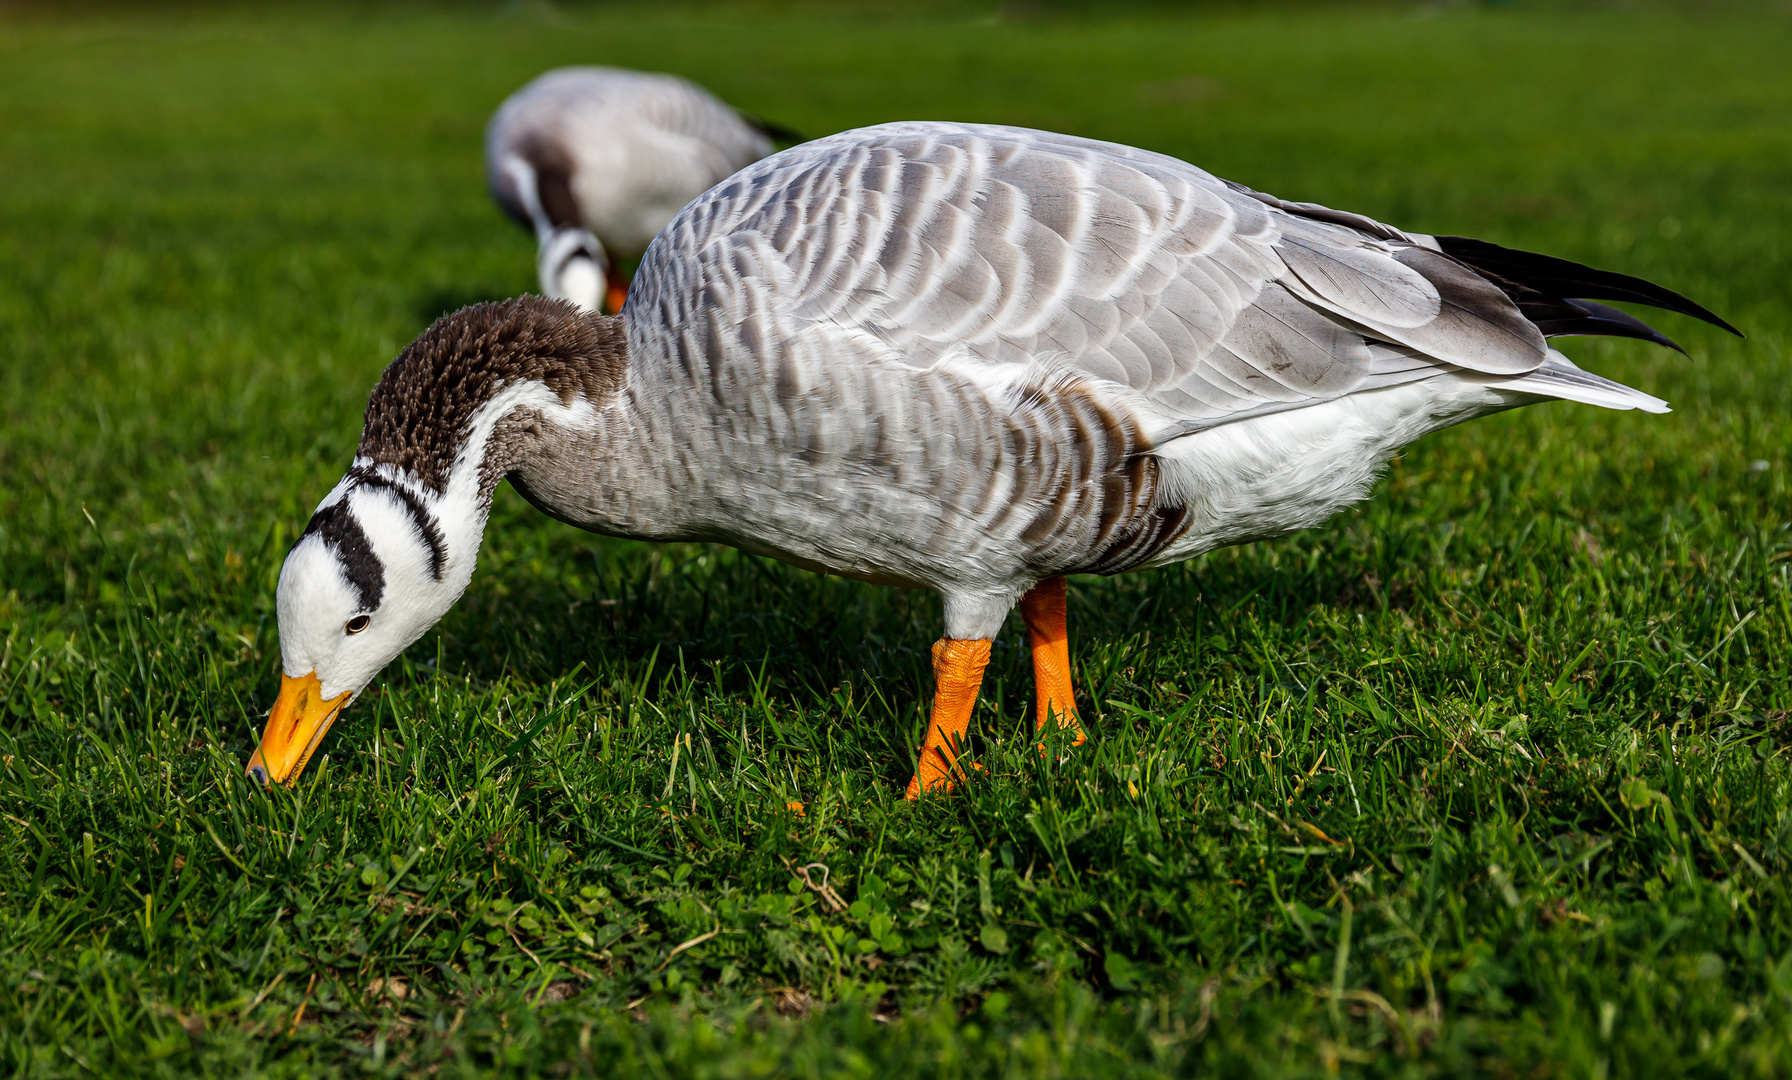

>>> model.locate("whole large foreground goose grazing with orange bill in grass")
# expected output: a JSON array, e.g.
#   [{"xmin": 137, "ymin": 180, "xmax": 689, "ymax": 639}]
[{"xmin": 249, "ymin": 124, "xmax": 1731, "ymax": 797}]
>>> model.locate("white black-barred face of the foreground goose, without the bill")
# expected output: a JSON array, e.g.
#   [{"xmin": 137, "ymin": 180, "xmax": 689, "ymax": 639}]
[{"xmin": 276, "ymin": 478, "xmax": 471, "ymax": 699}]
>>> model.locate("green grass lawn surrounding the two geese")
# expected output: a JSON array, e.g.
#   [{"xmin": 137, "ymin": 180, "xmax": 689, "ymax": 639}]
[{"xmin": 0, "ymin": 4, "xmax": 1792, "ymax": 1078}]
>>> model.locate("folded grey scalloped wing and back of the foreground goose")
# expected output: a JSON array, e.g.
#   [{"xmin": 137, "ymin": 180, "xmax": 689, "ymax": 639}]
[{"xmin": 629, "ymin": 124, "xmax": 1615, "ymax": 437}]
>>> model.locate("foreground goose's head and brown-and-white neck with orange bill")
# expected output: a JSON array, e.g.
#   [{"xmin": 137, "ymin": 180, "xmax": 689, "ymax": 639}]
[{"xmin": 247, "ymin": 297, "xmax": 625, "ymax": 783}]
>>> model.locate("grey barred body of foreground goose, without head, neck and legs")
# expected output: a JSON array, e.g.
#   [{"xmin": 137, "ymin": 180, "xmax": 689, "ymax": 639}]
[{"xmin": 598, "ymin": 124, "xmax": 1720, "ymax": 632}]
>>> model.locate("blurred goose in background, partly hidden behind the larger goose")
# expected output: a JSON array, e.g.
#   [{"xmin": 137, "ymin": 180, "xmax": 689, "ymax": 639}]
[{"xmin": 486, "ymin": 68, "xmax": 785, "ymax": 312}]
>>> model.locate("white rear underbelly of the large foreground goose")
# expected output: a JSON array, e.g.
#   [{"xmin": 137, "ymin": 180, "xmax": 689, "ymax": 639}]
[{"xmin": 1142, "ymin": 374, "xmax": 1536, "ymax": 566}]
